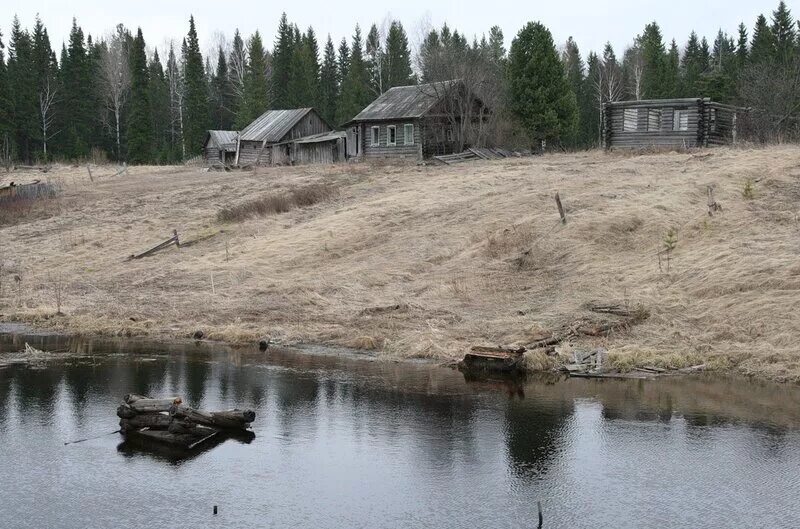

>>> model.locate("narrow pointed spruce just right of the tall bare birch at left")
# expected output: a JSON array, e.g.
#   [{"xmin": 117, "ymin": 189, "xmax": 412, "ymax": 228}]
[{"xmin": 127, "ymin": 28, "xmax": 154, "ymax": 164}]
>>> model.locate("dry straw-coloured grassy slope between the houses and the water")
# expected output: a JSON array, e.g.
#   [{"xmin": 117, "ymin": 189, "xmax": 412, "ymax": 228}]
[{"xmin": 0, "ymin": 147, "xmax": 800, "ymax": 381}]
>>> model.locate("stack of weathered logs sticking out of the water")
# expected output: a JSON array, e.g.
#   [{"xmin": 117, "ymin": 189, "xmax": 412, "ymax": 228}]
[{"xmin": 117, "ymin": 394, "xmax": 256, "ymax": 449}]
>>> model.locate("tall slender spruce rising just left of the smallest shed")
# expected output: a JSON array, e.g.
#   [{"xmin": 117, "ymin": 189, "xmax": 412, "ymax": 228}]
[{"xmin": 183, "ymin": 16, "xmax": 209, "ymax": 155}]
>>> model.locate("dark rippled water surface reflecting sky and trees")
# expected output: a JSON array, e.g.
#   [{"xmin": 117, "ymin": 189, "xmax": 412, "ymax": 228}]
[{"xmin": 0, "ymin": 328, "xmax": 800, "ymax": 529}]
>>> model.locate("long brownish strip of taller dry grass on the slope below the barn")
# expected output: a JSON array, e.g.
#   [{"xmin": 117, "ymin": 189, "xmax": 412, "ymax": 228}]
[{"xmin": 217, "ymin": 184, "xmax": 339, "ymax": 222}]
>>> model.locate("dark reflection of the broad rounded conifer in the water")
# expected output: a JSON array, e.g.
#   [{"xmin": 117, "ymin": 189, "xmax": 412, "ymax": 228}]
[{"xmin": 505, "ymin": 399, "xmax": 575, "ymax": 479}]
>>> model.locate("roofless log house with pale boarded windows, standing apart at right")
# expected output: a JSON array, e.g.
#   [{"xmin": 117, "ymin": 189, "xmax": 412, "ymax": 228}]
[{"xmin": 601, "ymin": 98, "xmax": 743, "ymax": 149}]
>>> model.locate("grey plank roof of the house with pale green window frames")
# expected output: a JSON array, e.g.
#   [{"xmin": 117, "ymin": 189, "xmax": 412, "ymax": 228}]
[{"xmin": 350, "ymin": 80, "xmax": 460, "ymax": 123}]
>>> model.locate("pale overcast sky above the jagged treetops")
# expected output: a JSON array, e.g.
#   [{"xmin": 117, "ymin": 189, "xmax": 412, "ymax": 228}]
[{"xmin": 0, "ymin": 0, "xmax": 788, "ymax": 57}]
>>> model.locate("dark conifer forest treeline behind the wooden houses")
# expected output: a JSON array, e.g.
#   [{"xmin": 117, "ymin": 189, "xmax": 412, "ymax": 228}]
[{"xmin": 0, "ymin": 2, "xmax": 800, "ymax": 163}]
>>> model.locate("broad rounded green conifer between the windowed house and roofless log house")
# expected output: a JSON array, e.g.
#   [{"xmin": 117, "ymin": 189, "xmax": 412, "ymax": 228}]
[{"xmin": 508, "ymin": 22, "xmax": 577, "ymax": 148}]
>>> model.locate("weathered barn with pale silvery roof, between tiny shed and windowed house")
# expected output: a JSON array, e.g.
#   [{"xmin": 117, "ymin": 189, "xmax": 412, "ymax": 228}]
[{"xmin": 236, "ymin": 108, "xmax": 333, "ymax": 166}]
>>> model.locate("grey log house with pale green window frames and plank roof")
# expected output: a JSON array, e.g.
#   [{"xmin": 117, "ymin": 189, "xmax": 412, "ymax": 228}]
[{"xmin": 345, "ymin": 80, "xmax": 485, "ymax": 161}]
